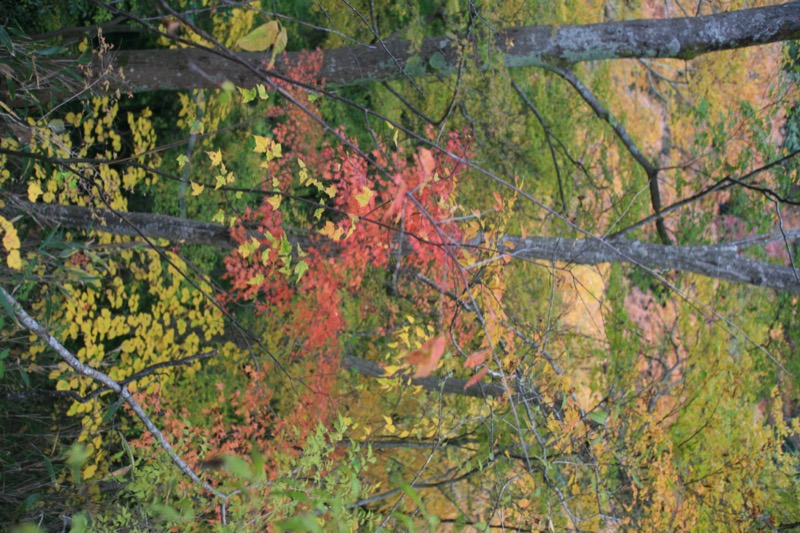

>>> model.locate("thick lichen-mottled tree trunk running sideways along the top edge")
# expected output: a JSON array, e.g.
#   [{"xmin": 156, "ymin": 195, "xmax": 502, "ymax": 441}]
[{"xmin": 100, "ymin": 2, "xmax": 800, "ymax": 91}]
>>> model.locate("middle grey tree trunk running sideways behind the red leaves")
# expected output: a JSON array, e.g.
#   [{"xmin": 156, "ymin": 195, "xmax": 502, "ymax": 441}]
[{"xmin": 0, "ymin": 200, "xmax": 800, "ymax": 293}]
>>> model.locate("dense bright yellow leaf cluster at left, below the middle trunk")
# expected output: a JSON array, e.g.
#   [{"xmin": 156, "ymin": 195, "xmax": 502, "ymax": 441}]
[{"xmin": 40, "ymin": 250, "xmax": 224, "ymax": 475}]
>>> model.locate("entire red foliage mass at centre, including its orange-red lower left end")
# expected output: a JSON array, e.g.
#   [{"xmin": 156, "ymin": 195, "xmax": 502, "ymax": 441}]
[{"xmin": 167, "ymin": 55, "xmax": 476, "ymax": 494}]
